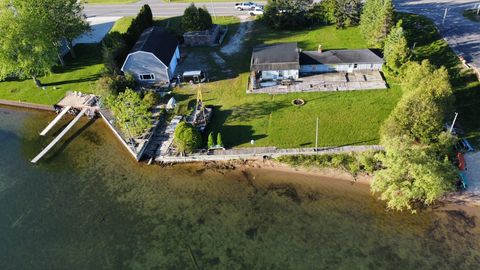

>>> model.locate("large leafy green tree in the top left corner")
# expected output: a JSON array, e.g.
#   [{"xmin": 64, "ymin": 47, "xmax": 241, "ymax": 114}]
[{"xmin": 0, "ymin": 0, "xmax": 62, "ymax": 86}]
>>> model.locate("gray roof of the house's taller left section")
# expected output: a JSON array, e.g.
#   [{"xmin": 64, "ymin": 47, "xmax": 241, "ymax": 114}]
[{"xmin": 251, "ymin": 42, "xmax": 300, "ymax": 71}]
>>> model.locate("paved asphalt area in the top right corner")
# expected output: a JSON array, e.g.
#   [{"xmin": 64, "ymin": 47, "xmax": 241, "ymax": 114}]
[{"xmin": 394, "ymin": 0, "xmax": 480, "ymax": 68}]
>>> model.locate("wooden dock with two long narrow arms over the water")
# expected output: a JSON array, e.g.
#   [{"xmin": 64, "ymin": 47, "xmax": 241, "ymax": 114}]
[{"xmin": 31, "ymin": 92, "xmax": 100, "ymax": 163}]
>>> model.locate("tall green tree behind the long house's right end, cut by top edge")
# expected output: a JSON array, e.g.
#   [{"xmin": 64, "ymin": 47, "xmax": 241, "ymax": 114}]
[{"xmin": 360, "ymin": 0, "xmax": 394, "ymax": 48}]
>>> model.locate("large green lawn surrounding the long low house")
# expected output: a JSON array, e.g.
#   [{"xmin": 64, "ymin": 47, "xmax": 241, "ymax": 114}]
[{"xmin": 175, "ymin": 22, "xmax": 402, "ymax": 147}]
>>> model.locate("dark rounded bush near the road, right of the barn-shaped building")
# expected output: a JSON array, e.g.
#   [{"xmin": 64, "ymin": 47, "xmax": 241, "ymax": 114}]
[{"xmin": 181, "ymin": 3, "xmax": 212, "ymax": 32}]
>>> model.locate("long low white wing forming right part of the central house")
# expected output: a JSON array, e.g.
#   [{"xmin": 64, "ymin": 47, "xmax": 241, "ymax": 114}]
[{"xmin": 300, "ymin": 49, "xmax": 384, "ymax": 73}]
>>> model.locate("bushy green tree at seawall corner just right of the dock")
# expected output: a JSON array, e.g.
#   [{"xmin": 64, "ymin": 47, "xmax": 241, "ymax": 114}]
[{"xmin": 107, "ymin": 88, "xmax": 152, "ymax": 137}]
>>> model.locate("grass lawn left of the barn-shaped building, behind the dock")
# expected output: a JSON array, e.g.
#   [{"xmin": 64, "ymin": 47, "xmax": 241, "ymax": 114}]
[{"xmin": 0, "ymin": 45, "xmax": 103, "ymax": 105}]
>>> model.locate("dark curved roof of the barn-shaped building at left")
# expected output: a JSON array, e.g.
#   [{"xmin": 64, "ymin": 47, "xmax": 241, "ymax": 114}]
[{"xmin": 130, "ymin": 26, "xmax": 178, "ymax": 66}]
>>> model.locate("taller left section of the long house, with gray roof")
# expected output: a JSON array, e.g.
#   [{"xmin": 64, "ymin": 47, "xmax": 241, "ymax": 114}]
[{"xmin": 251, "ymin": 42, "xmax": 300, "ymax": 80}]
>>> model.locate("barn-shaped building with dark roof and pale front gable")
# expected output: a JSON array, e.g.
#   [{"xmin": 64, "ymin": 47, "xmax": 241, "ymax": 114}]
[{"xmin": 121, "ymin": 26, "xmax": 180, "ymax": 85}]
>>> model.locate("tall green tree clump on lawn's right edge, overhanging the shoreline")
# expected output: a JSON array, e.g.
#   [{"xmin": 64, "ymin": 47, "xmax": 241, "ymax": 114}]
[{"xmin": 372, "ymin": 61, "xmax": 456, "ymax": 210}]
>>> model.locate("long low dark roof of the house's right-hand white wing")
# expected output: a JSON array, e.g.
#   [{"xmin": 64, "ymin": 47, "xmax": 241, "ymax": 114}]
[{"xmin": 300, "ymin": 49, "xmax": 384, "ymax": 65}]
